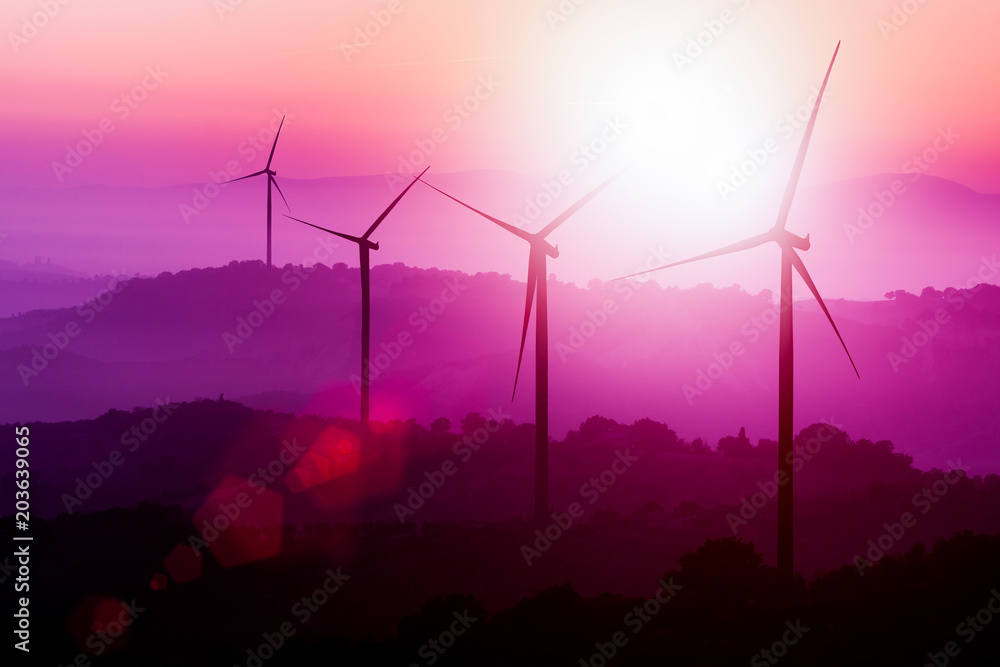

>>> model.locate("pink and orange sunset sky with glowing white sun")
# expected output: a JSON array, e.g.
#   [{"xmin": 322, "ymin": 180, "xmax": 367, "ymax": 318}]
[{"xmin": 0, "ymin": 0, "xmax": 1000, "ymax": 290}]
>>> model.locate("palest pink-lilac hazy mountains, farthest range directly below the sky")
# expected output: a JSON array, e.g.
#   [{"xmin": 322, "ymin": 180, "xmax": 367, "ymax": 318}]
[{"xmin": 0, "ymin": 172, "xmax": 1000, "ymax": 300}]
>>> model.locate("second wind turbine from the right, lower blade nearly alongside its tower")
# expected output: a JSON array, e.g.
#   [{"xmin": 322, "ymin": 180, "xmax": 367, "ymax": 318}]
[{"xmin": 418, "ymin": 165, "xmax": 631, "ymax": 526}]
